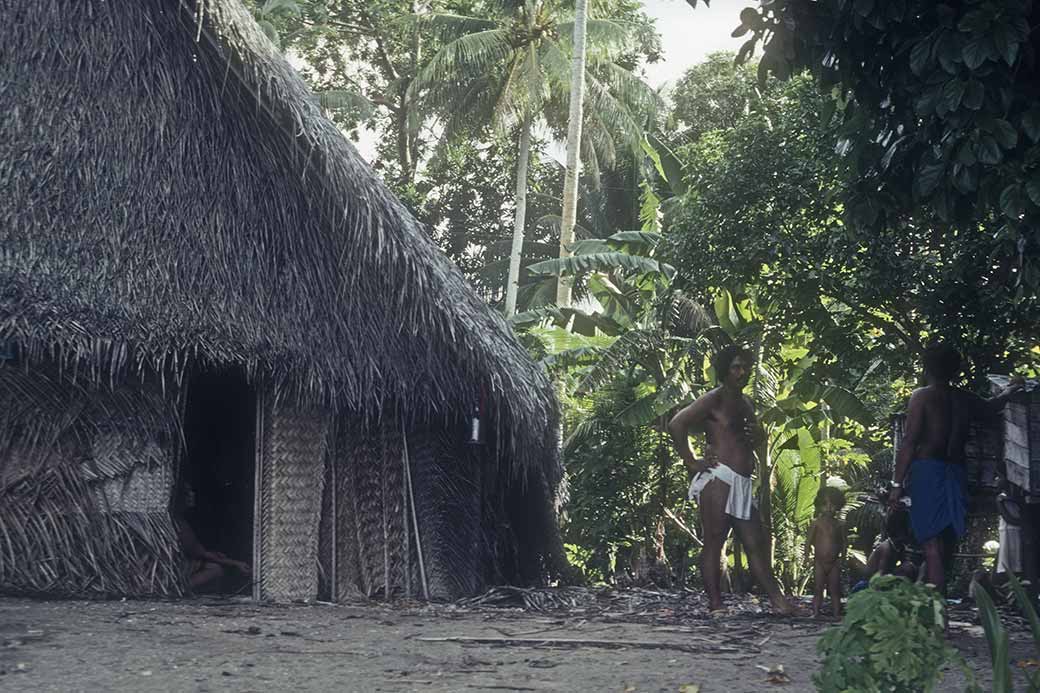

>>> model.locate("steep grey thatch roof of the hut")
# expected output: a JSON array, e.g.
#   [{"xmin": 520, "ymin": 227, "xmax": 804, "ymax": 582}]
[{"xmin": 0, "ymin": 0, "xmax": 558, "ymax": 474}]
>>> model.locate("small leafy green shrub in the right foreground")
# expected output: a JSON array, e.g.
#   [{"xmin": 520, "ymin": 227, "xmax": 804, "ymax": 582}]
[{"xmin": 812, "ymin": 575, "xmax": 972, "ymax": 693}]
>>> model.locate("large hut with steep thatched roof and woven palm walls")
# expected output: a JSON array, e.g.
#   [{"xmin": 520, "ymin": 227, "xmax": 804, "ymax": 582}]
[{"xmin": 0, "ymin": 0, "xmax": 561, "ymax": 597}]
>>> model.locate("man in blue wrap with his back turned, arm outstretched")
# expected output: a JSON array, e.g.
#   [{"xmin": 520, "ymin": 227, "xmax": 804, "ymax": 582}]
[{"xmin": 889, "ymin": 344, "xmax": 1022, "ymax": 592}]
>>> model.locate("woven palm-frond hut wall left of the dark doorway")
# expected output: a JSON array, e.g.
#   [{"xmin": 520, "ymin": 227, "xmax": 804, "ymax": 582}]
[{"xmin": 0, "ymin": 365, "xmax": 182, "ymax": 596}]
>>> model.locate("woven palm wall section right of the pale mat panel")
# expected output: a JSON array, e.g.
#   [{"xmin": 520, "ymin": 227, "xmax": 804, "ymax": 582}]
[{"xmin": 319, "ymin": 418, "xmax": 487, "ymax": 600}]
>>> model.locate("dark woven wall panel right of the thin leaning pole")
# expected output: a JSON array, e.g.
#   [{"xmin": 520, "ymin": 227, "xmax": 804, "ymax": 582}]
[{"xmin": 409, "ymin": 430, "xmax": 485, "ymax": 599}]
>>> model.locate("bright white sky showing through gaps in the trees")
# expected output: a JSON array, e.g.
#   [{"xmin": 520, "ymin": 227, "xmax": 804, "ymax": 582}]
[{"xmin": 356, "ymin": 0, "xmax": 754, "ymax": 162}]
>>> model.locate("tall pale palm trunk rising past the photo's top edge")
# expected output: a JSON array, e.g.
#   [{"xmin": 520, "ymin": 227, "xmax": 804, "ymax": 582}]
[{"xmin": 556, "ymin": 0, "xmax": 588, "ymax": 308}]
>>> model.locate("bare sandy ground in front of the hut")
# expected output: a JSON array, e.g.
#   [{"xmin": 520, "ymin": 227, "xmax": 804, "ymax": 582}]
[{"xmin": 0, "ymin": 586, "xmax": 1035, "ymax": 693}]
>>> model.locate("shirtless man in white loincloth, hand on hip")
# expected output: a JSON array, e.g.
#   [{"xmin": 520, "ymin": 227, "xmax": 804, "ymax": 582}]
[{"xmin": 668, "ymin": 345, "xmax": 794, "ymax": 614}]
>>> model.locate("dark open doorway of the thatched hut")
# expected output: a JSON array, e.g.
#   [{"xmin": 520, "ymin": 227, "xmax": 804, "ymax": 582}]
[{"xmin": 180, "ymin": 370, "xmax": 257, "ymax": 593}]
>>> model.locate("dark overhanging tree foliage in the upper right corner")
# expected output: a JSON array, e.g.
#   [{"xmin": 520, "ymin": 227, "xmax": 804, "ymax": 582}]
[{"xmin": 734, "ymin": 0, "xmax": 1040, "ymax": 378}]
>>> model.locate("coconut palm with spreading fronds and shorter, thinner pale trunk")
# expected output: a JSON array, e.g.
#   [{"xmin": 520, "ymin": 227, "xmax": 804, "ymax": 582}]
[{"xmin": 412, "ymin": 0, "xmax": 657, "ymax": 315}]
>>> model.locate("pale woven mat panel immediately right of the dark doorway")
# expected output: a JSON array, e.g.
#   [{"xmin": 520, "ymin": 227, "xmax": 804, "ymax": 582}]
[{"xmin": 258, "ymin": 397, "xmax": 331, "ymax": 600}]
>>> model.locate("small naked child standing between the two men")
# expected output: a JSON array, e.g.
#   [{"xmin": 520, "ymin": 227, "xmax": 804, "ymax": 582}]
[{"xmin": 805, "ymin": 486, "xmax": 846, "ymax": 618}]
